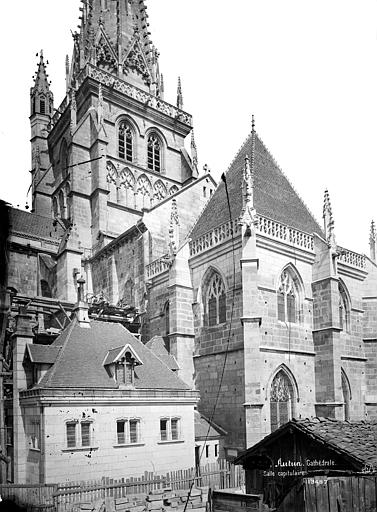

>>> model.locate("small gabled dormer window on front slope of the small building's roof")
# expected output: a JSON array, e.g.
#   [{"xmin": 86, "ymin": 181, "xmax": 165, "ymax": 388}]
[{"xmin": 103, "ymin": 345, "xmax": 143, "ymax": 387}]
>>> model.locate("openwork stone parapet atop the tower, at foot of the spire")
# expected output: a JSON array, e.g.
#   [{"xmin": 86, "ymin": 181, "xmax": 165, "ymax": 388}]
[{"xmin": 70, "ymin": 64, "xmax": 192, "ymax": 127}]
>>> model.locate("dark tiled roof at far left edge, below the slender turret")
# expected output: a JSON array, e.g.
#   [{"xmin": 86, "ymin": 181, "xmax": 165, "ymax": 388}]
[{"xmin": 10, "ymin": 208, "xmax": 64, "ymax": 240}]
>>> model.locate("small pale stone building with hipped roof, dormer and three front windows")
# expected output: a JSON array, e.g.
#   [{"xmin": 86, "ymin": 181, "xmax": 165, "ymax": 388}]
[{"xmin": 7, "ymin": 304, "xmax": 198, "ymax": 484}]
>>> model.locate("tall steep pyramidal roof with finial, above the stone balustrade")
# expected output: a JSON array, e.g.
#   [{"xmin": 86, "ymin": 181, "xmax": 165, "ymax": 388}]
[{"xmin": 190, "ymin": 133, "xmax": 322, "ymax": 240}]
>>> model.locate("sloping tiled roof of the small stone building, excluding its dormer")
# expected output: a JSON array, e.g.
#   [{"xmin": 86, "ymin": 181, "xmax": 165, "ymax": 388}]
[{"xmin": 37, "ymin": 319, "xmax": 190, "ymax": 390}]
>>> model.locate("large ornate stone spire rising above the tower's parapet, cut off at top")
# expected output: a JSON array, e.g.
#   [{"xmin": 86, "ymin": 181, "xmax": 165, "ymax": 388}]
[{"xmin": 71, "ymin": 0, "xmax": 161, "ymax": 96}]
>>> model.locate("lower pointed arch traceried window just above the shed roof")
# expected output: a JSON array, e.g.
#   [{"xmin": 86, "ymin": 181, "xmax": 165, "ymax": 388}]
[{"xmin": 270, "ymin": 370, "xmax": 294, "ymax": 432}]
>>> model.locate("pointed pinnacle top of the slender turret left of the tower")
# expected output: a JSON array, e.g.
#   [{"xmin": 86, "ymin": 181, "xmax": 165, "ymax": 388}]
[{"xmin": 30, "ymin": 50, "xmax": 54, "ymax": 117}]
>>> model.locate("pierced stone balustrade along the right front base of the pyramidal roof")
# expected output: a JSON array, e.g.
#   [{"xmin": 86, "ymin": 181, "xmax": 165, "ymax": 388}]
[{"xmin": 257, "ymin": 215, "xmax": 314, "ymax": 252}]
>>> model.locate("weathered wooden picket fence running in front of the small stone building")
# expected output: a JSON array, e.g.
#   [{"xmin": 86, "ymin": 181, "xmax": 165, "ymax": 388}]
[{"xmin": 0, "ymin": 460, "xmax": 245, "ymax": 512}]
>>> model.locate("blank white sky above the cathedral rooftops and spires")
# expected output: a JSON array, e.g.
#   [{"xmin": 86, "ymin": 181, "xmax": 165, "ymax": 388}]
[{"xmin": 0, "ymin": 0, "xmax": 377, "ymax": 253}]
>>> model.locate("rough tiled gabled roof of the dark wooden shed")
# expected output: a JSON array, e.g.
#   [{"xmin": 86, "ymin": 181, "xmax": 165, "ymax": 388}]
[{"xmin": 233, "ymin": 418, "xmax": 377, "ymax": 465}]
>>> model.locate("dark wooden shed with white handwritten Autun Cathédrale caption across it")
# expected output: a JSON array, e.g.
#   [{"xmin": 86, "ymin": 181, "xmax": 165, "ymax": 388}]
[{"xmin": 234, "ymin": 418, "xmax": 377, "ymax": 512}]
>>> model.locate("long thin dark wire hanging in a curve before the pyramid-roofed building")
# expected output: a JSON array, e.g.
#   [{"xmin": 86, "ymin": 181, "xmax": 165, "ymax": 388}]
[{"xmin": 183, "ymin": 173, "xmax": 236, "ymax": 512}]
